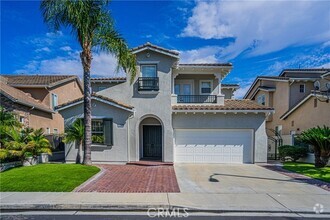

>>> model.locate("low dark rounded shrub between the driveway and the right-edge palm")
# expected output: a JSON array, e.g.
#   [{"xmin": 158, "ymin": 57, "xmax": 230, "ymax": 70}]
[{"xmin": 278, "ymin": 145, "xmax": 308, "ymax": 162}]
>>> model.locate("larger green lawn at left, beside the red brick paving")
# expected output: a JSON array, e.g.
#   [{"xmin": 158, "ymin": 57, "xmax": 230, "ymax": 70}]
[{"xmin": 0, "ymin": 164, "xmax": 100, "ymax": 192}]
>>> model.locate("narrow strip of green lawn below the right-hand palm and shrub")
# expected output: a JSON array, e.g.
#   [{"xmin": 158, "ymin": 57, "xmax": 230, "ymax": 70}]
[{"xmin": 283, "ymin": 162, "xmax": 330, "ymax": 183}]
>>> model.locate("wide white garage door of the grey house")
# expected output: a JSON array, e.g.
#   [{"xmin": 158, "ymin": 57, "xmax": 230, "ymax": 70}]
[{"xmin": 174, "ymin": 129, "xmax": 253, "ymax": 163}]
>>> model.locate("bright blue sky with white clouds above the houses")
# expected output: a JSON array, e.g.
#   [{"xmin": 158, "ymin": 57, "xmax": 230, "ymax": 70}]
[{"xmin": 1, "ymin": 1, "xmax": 330, "ymax": 97}]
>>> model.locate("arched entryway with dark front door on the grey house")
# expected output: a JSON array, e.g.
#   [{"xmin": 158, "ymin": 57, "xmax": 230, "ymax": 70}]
[{"xmin": 139, "ymin": 116, "xmax": 163, "ymax": 161}]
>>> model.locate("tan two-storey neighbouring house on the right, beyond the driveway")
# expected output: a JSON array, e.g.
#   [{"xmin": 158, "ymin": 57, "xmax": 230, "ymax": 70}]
[{"xmin": 244, "ymin": 69, "xmax": 330, "ymax": 157}]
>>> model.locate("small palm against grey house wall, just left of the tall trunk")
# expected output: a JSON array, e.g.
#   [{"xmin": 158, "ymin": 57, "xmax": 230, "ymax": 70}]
[{"xmin": 64, "ymin": 118, "xmax": 85, "ymax": 163}]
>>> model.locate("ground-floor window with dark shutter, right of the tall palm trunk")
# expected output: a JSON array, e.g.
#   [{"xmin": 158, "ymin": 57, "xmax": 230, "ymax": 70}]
[{"xmin": 92, "ymin": 119, "xmax": 113, "ymax": 145}]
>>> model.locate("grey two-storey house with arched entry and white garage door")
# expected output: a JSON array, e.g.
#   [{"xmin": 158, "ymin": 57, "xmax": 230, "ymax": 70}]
[{"xmin": 57, "ymin": 43, "xmax": 273, "ymax": 163}]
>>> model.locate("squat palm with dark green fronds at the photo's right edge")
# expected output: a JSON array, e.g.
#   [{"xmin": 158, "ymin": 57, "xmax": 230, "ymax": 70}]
[{"xmin": 298, "ymin": 126, "xmax": 330, "ymax": 167}]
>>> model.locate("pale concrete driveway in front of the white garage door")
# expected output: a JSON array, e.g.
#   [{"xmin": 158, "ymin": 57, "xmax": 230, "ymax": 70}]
[{"xmin": 175, "ymin": 164, "xmax": 330, "ymax": 195}]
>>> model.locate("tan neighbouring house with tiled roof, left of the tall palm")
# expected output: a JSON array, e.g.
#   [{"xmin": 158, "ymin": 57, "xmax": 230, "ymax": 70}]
[{"xmin": 0, "ymin": 75, "xmax": 83, "ymax": 134}]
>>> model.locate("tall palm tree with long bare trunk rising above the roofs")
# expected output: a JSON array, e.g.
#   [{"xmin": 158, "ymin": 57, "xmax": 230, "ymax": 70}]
[{"xmin": 40, "ymin": 0, "xmax": 136, "ymax": 165}]
